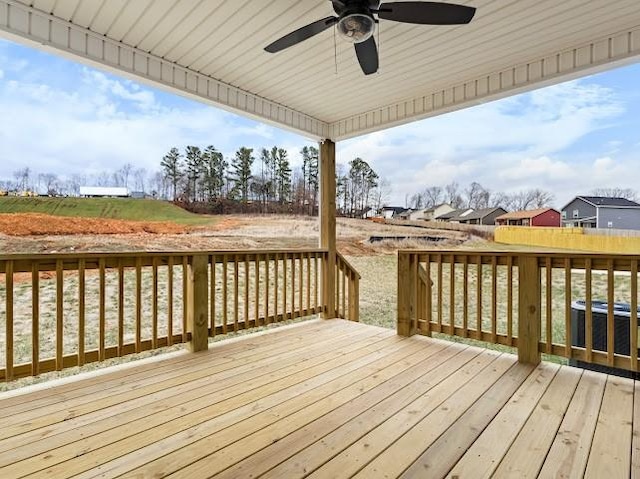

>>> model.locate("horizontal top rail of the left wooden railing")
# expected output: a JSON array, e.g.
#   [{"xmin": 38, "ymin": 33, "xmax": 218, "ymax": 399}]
[{"xmin": 0, "ymin": 248, "xmax": 327, "ymax": 261}]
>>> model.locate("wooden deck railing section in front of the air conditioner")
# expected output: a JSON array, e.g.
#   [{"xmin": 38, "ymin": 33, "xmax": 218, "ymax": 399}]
[{"xmin": 398, "ymin": 251, "xmax": 640, "ymax": 371}]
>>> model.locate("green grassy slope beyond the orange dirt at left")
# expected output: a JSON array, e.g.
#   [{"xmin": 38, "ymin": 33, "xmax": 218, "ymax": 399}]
[{"xmin": 0, "ymin": 197, "xmax": 214, "ymax": 226}]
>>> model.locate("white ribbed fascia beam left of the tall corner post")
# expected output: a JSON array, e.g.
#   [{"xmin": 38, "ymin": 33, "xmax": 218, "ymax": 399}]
[{"xmin": 0, "ymin": 0, "xmax": 329, "ymax": 141}]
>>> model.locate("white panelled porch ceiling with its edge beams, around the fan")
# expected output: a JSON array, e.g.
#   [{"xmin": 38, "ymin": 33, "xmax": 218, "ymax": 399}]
[{"xmin": 0, "ymin": 0, "xmax": 640, "ymax": 140}]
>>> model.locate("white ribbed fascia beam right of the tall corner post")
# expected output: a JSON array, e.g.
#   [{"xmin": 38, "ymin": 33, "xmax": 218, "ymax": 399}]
[{"xmin": 329, "ymin": 26, "xmax": 640, "ymax": 141}]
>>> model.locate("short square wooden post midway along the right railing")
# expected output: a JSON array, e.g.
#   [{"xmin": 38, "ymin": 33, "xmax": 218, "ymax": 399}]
[{"xmin": 518, "ymin": 256, "xmax": 542, "ymax": 364}]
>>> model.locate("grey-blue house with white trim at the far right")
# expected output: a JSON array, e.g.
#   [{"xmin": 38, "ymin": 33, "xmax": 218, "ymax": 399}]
[{"xmin": 562, "ymin": 196, "xmax": 640, "ymax": 230}]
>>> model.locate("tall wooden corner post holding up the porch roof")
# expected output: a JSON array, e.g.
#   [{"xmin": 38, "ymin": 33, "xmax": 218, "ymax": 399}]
[{"xmin": 320, "ymin": 140, "xmax": 337, "ymax": 319}]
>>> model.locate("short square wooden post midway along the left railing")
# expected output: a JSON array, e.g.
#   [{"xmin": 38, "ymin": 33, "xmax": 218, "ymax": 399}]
[{"xmin": 187, "ymin": 255, "xmax": 209, "ymax": 352}]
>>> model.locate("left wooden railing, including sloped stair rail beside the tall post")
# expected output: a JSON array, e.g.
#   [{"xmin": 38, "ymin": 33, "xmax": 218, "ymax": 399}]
[{"xmin": 0, "ymin": 250, "xmax": 359, "ymax": 380}]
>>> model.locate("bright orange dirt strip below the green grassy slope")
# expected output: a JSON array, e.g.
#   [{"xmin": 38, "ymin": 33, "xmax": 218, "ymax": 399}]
[{"xmin": 0, "ymin": 213, "xmax": 188, "ymax": 236}]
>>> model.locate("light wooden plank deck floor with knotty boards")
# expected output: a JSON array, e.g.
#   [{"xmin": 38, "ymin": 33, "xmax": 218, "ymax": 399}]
[{"xmin": 0, "ymin": 320, "xmax": 640, "ymax": 479}]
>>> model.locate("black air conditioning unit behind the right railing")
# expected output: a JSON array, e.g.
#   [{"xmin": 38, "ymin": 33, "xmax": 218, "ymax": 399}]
[{"xmin": 569, "ymin": 301, "xmax": 640, "ymax": 377}]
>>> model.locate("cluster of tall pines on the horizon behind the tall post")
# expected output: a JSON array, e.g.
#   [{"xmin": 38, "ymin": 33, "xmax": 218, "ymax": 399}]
[{"xmin": 160, "ymin": 146, "xmax": 385, "ymax": 216}]
